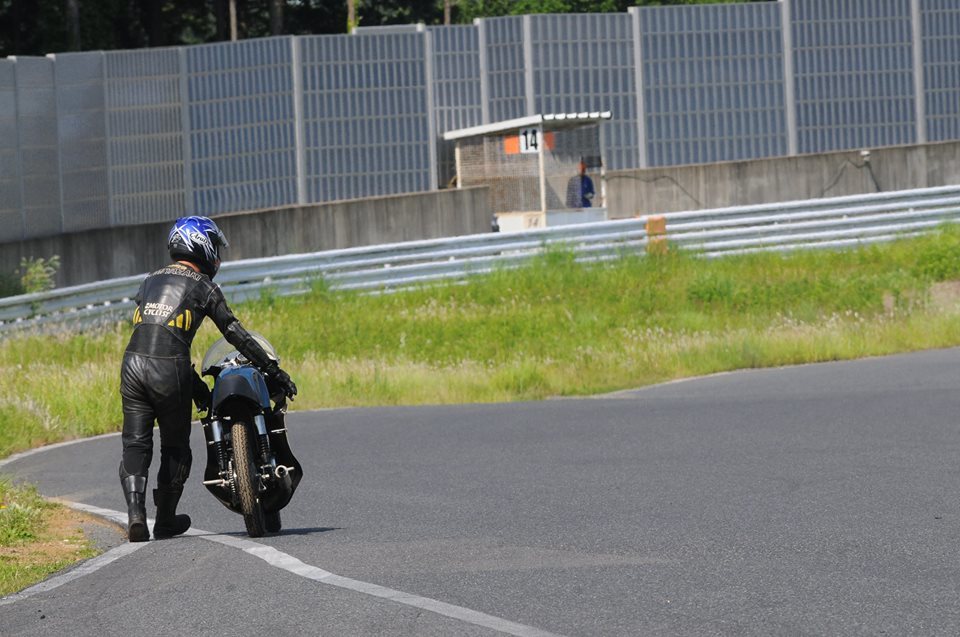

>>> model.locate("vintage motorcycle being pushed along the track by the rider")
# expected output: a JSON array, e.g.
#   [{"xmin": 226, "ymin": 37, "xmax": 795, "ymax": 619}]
[{"xmin": 200, "ymin": 332, "xmax": 303, "ymax": 537}]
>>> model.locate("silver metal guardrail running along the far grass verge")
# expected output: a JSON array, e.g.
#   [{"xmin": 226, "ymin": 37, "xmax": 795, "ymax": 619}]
[{"xmin": 0, "ymin": 186, "xmax": 960, "ymax": 335}]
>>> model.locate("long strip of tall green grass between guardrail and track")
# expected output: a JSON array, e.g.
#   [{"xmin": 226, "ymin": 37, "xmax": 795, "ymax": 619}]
[{"xmin": 0, "ymin": 228, "xmax": 960, "ymax": 457}]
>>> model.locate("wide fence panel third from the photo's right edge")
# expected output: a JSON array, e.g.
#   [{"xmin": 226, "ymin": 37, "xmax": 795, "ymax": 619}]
[{"xmin": 637, "ymin": 3, "xmax": 787, "ymax": 166}]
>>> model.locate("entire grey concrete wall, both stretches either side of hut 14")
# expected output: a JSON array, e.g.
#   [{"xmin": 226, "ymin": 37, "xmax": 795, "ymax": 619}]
[{"xmin": 7, "ymin": 142, "xmax": 960, "ymax": 287}]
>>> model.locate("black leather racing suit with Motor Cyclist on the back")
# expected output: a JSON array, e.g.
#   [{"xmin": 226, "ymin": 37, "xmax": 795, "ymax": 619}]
[{"xmin": 120, "ymin": 263, "xmax": 278, "ymax": 489}]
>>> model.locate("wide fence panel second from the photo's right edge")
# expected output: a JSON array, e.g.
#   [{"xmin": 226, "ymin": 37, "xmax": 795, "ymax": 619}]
[{"xmin": 791, "ymin": 0, "xmax": 917, "ymax": 153}]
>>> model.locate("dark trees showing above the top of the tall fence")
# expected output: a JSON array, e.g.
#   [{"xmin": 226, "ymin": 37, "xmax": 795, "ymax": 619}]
[{"xmin": 0, "ymin": 0, "xmax": 770, "ymax": 57}]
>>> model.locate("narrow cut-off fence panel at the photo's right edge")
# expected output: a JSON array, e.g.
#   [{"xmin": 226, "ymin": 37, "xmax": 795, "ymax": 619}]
[{"xmin": 920, "ymin": 0, "xmax": 960, "ymax": 142}]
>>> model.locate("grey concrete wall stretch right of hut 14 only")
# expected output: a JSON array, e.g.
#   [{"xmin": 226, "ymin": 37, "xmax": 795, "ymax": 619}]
[{"xmin": 607, "ymin": 142, "xmax": 960, "ymax": 218}]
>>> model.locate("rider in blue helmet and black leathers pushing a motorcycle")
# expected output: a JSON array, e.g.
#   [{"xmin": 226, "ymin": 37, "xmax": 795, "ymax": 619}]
[{"xmin": 120, "ymin": 216, "xmax": 297, "ymax": 542}]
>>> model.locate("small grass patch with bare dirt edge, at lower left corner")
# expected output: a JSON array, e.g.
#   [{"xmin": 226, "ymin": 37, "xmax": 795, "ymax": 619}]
[{"xmin": 0, "ymin": 479, "xmax": 97, "ymax": 597}]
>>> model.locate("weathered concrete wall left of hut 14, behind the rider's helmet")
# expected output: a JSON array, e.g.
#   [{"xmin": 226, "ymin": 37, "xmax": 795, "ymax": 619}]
[{"xmin": 0, "ymin": 188, "xmax": 492, "ymax": 287}]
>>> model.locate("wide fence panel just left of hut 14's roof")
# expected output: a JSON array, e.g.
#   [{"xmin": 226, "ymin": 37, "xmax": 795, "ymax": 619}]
[{"xmin": 301, "ymin": 33, "xmax": 435, "ymax": 202}]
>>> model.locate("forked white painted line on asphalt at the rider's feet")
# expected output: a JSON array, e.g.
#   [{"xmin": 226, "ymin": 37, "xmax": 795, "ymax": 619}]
[{"xmin": 24, "ymin": 500, "xmax": 560, "ymax": 637}]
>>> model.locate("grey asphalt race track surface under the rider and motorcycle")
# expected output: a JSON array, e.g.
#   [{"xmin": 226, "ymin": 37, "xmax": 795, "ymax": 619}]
[{"xmin": 0, "ymin": 349, "xmax": 960, "ymax": 637}]
